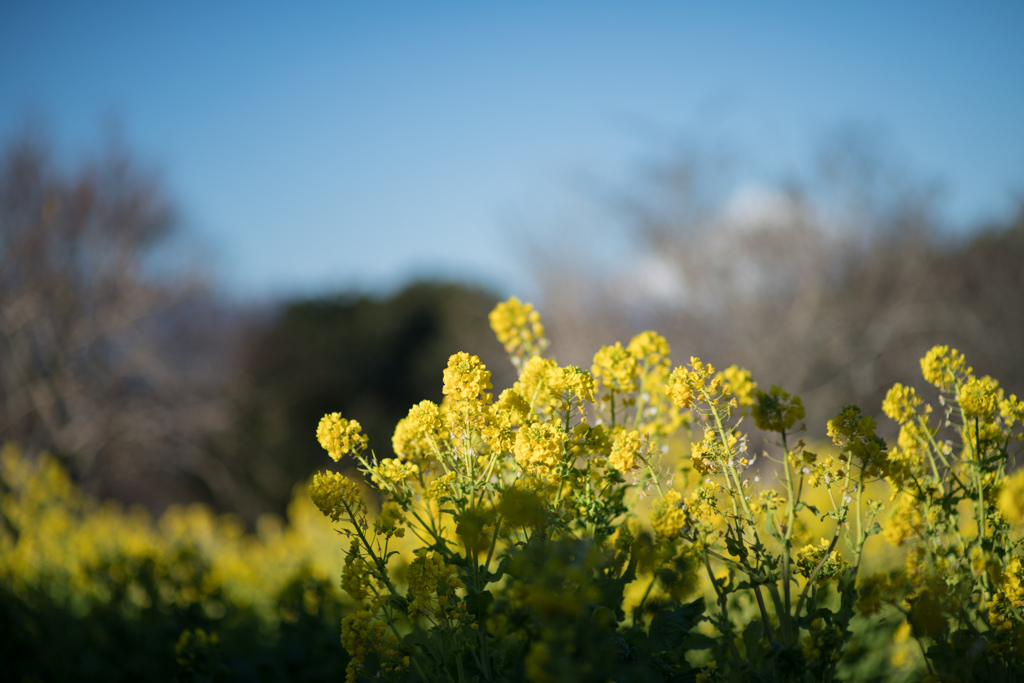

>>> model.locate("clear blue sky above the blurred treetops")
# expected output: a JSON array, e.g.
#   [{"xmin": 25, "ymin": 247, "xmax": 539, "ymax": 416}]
[{"xmin": 0, "ymin": 0, "xmax": 1024, "ymax": 296}]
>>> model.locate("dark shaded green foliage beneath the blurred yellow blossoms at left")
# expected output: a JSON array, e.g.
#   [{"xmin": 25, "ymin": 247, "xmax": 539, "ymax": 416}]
[{"xmin": 0, "ymin": 562, "xmax": 348, "ymax": 683}]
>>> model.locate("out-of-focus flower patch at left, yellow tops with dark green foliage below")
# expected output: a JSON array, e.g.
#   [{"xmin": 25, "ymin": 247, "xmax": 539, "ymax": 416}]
[{"xmin": 0, "ymin": 445, "xmax": 348, "ymax": 681}]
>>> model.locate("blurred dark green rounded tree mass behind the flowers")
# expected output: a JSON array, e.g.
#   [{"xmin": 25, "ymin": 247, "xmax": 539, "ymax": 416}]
[{"xmin": 223, "ymin": 283, "xmax": 514, "ymax": 516}]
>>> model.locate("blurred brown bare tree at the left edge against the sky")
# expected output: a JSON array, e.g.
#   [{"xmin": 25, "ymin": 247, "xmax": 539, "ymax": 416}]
[{"xmin": 0, "ymin": 133, "xmax": 229, "ymax": 505}]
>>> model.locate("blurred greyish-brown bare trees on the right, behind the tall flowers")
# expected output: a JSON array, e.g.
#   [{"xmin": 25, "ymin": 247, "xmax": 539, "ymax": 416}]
[{"xmin": 532, "ymin": 130, "xmax": 1024, "ymax": 435}]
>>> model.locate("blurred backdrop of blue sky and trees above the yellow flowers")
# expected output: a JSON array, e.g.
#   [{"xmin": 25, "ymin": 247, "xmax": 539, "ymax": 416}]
[{"xmin": 0, "ymin": 2, "xmax": 1024, "ymax": 525}]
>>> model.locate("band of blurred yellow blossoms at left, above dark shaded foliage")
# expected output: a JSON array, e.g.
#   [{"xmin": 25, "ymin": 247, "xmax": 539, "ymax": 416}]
[{"xmin": 0, "ymin": 444, "xmax": 344, "ymax": 634}]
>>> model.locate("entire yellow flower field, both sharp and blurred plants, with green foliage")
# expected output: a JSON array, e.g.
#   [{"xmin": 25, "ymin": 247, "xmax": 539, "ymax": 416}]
[{"xmin": 0, "ymin": 299, "xmax": 1024, "ymax": 683}]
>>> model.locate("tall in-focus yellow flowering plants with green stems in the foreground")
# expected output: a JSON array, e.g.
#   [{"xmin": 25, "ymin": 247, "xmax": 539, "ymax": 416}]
[{"xmin": 312, "ymin": 299, "xmax": 1024, "ymax": 680}]
